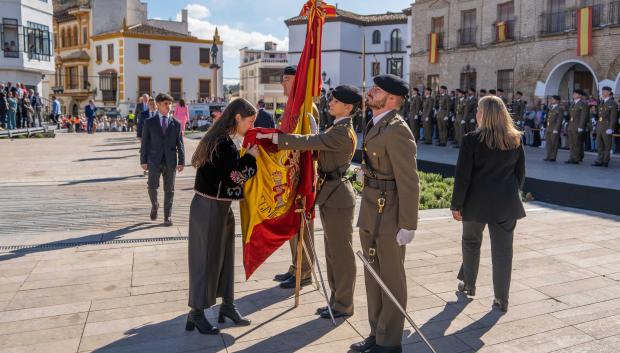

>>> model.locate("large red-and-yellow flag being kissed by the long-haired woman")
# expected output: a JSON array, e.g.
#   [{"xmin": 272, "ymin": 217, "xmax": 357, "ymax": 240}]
[{"xmin": 240, "ymin": 0, "xmax": 336, "ymax": 279}]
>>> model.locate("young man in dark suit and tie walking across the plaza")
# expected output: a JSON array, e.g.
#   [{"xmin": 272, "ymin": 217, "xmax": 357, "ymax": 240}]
[{"xmin": 140, "ymin": 93, "xmax": 185, "ymax": 226}]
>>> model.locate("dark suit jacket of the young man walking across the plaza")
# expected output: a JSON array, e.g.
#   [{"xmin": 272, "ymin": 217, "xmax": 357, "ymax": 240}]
[{"xmin": 140, "ymin": 114, "xmax": 185, "ymax": 168}]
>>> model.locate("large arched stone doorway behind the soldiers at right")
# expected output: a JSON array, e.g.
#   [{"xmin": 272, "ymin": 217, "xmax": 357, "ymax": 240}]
[{"xmin": 544, "ymin": 60, "xmax": 599, "ymax": 98}]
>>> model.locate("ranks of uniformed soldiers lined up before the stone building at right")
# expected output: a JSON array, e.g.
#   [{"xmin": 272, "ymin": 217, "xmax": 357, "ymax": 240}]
[{"xmin": 401, "ymin": 86, "xmax": 620, "ymax": 167}]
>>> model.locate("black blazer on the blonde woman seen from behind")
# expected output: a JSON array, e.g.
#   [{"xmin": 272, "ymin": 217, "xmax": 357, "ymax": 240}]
[{"xmin": 451, "ymin": 131, "xmax": 525, "ymax": 223}]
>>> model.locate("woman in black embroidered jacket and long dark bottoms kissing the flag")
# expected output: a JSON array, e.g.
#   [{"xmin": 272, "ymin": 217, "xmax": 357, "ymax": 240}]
[{"xmin": 186, "ymin": 99, "xmax": 258, "ymax": 334}]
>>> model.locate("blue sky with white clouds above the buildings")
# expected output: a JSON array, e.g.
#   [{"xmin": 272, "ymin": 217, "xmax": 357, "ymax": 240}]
[{"xmin": 143, "ymin": 0, "xmax": 412, "ymax": 83}]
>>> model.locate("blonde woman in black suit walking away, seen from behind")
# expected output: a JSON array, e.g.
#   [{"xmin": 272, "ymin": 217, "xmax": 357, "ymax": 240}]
[{"xmin": 451, "ymin": 96, "xmax": 525, "ymax": 312}]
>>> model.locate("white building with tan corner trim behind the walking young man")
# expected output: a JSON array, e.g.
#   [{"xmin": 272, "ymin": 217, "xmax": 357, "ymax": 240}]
[{"xmin": 91, "ymin": 24, "xmax": 223, "ymax": 114}]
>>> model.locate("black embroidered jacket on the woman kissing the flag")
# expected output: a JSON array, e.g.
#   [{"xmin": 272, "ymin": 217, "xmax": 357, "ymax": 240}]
[{"xmin": 194, "ymin": 136, "xmax": 257, "ymax": 200}]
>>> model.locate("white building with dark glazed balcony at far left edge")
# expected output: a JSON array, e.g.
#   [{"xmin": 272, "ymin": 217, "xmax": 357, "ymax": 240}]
[{"xmin": 0, "ymin": 0, "xmax": 54, "ymax": 92}]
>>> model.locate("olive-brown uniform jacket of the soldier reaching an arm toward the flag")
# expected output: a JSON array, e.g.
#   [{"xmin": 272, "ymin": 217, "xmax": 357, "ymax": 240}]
[{"xmin": 278, "ymin": 118, "xmax": 357, "ymax": 208}]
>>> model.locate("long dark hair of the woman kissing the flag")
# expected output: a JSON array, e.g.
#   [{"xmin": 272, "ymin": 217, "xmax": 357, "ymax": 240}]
[{"xmin": 192, "ymin": 98, "xmax": 256, "ymax": 168}]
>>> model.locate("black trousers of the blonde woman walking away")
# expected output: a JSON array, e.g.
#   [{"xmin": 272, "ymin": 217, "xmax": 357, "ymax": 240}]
[{"xmin": 458, "ymin": 219, "xmax": 517, "ymax": 303}]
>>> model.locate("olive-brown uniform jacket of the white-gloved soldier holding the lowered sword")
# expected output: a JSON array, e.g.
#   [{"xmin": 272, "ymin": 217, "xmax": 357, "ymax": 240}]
[{"xmin": 357, "ymin": 111, "xmax": 420, "ymax": 236}]
